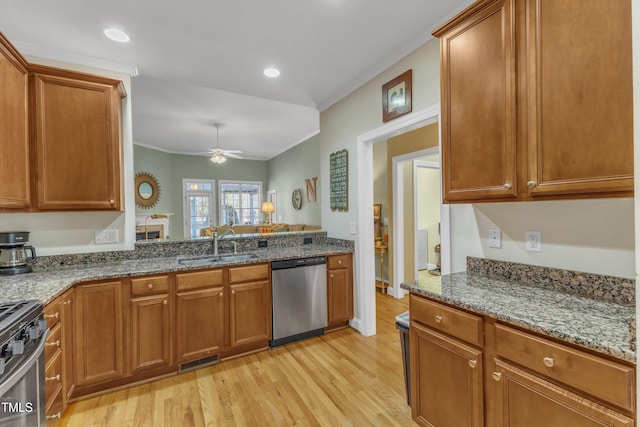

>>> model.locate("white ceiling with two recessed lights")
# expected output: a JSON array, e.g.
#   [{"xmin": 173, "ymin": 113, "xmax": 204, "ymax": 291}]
[{"xmin": 0, "ymin": 0, "xmax": 472, "ymax": 160}]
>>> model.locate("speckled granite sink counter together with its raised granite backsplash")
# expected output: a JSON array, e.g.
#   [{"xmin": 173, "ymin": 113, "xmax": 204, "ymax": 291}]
[{"xmin": 0, "ymin": 234, "xmax": 353, "ymax": 310}]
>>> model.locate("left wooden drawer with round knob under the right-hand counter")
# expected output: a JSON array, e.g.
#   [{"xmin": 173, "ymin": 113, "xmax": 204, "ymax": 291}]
[{"xmin": 409, "ymin": 294, "xmax": 483, "ymax": 347}]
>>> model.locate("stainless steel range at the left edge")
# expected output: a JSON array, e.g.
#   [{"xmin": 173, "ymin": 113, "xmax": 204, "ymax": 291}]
[{"xmin": 0, "ymin": 300, "xmax": 49, "ymax": 427}]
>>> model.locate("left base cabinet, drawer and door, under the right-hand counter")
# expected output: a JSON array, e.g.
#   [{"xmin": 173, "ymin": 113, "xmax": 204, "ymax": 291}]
[{"xmin": 409, "ymin": 294, "xmax": 485, "ymax": 427}]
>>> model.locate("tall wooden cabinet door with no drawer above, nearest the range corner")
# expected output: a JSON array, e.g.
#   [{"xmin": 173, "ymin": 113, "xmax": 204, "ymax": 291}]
[{"xmin": 74, "ymin": 281, "xmax": 125, "ymax": 386}]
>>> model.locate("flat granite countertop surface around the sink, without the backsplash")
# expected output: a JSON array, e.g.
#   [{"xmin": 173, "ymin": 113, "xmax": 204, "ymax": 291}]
[{"xmin": 0, "ymin": 244, "xmax": 352, "ymax": 304}]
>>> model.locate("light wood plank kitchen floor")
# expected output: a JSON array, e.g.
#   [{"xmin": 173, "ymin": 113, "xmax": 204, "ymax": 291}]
[{"xmin": 61, "ymin": 292, "xmax": 415, "ymax": 427}]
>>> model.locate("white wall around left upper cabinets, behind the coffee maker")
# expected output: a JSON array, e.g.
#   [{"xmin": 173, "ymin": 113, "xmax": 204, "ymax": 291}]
[{"xmin": 0, "ymin": 55, "xmax": 135, "ymax": 255}]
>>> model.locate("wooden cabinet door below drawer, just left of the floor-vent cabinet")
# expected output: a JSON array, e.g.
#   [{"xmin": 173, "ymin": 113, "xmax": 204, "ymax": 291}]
[{"xmin": 129, "ymin": 294, "xmax": 171, "ymax": 373}]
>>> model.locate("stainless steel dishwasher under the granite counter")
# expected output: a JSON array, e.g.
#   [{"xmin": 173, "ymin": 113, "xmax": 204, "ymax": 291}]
[{"xmin": 269, "ymin": 256, "xmax": 327, "ymax": 347}]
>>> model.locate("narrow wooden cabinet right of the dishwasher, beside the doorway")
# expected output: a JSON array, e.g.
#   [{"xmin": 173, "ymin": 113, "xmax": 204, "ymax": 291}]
[{"xmin": 326, "ymin": 254, "xmax": 353, "ymax": 330}]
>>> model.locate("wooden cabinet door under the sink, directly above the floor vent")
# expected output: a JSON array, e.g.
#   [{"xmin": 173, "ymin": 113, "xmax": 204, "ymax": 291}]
[{"xmin": 176, "ymin": 286, "xmax": 226, "ymax": 362}]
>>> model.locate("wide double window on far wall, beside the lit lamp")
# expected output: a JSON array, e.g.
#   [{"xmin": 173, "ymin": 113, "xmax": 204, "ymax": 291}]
[{"xmin": 219, "ymin": 181, "xmax": 262, "ymax": 224}]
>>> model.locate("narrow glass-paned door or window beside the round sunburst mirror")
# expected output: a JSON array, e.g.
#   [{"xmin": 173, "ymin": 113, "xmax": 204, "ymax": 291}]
[{"xmin": 182, "ymin": 179, "xmax": 216, "ymax": 239}]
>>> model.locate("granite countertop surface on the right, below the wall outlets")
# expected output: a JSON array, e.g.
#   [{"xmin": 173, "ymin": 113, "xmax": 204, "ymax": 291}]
[{"xmin": 401, "ymin": 272, "xmax": 636, "ymax": 363}]
